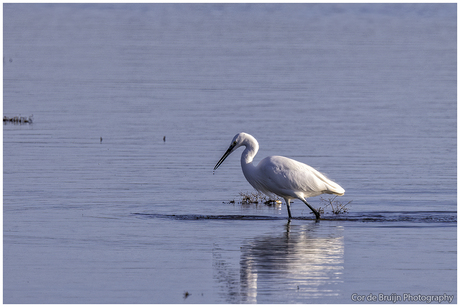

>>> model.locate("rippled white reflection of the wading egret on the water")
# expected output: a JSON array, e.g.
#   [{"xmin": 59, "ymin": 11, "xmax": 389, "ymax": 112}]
[{"xmin": 213, "ymin": 222, "xmax": 344, "ymax": 303}]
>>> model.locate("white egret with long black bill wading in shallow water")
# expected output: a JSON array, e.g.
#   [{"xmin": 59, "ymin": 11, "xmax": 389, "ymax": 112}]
[{"xmin": 214, "ymin": 132, "xmax": 345, "ymax": 219}]
